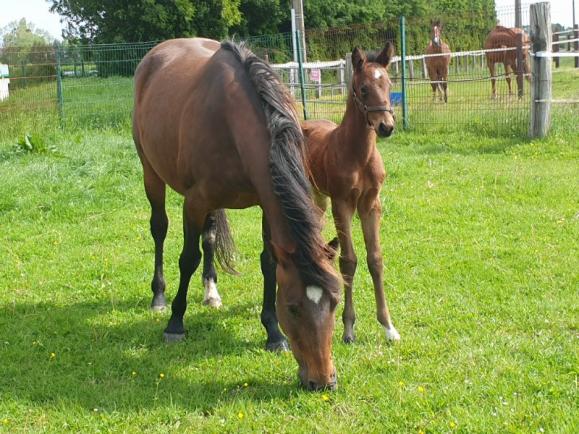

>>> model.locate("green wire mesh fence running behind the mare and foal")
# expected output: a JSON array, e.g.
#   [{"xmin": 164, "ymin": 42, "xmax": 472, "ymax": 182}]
[{"xmin": 0, "ymin": 4, "xmax": 579, "ymax": 142}]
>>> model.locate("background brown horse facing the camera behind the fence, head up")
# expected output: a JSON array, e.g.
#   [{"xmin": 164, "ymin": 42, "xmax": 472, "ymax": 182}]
[{"xmin": 424, "ymin": 21, "xmax": 450, "ymax": 102}]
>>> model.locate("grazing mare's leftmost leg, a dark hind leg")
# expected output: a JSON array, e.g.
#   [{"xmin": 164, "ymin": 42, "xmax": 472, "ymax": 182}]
[{"xmin": 143, "ymin": 161, "xmax": 169, "ymax": 310}]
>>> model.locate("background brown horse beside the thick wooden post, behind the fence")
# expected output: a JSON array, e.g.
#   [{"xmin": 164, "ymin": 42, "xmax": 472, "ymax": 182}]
[{"xmin": 484, "ymin": 26, "xmax": 530, "ymax": 98}]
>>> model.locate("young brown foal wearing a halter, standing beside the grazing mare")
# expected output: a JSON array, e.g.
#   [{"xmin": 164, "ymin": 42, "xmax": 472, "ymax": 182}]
[{"xmin": 302, "ymin": 43, "xmax": 400, "ymax": 343}]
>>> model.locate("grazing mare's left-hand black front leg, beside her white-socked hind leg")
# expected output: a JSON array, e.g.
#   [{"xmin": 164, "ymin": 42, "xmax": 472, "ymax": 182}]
[{"xmin": 165, "ymin": 198, "xmax": 205, "ymax": 342}]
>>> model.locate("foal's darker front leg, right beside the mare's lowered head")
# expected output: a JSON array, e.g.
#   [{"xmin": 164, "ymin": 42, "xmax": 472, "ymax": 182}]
[{"xmin": 332, "ymin": 198, "xmax": 358, "ymax": 344}]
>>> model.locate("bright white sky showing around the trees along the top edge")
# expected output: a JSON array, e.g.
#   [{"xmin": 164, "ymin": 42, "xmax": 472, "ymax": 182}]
[{"xmin": 0, "ymin": 0, "xmax": 579, "ymax": 39}]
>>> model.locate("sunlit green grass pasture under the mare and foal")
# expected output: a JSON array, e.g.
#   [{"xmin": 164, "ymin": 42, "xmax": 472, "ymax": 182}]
[{"xmin": 0, "ymin": 71, "xmax": 579, "ymax": 433}]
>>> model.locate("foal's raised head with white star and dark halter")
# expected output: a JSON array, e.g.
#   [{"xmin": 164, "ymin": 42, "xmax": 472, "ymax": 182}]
[{"xmin": 352, "ymin": 42, "xmax": 394, "ymax": 137}]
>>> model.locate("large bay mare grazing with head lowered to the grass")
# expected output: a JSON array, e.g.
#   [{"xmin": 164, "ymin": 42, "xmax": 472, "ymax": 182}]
[{"xmin": 133, "ymin": 38, "xmax": 340, "ymax": 389}]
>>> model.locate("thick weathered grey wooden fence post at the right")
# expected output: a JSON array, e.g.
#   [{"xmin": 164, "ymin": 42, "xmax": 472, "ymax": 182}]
[{"xmin": 529, "ymin": 2, "xmax": 552, "ymax": 137}]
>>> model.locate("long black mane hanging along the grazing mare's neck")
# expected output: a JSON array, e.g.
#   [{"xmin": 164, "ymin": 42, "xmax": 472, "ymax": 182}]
[{"xmin": 221, "ymin": 41, "xmax": 337, "ymax": 298}]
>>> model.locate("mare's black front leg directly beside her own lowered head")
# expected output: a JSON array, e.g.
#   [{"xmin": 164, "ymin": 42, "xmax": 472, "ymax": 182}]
[{"xmin": 259, "ymin": 216, "xmax": 289, "ymax": 351}]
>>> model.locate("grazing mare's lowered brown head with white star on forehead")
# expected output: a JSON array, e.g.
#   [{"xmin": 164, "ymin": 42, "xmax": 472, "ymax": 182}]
[{"xmin": 274, "ymin": 240, "xmax": 341, "ymax": 390}]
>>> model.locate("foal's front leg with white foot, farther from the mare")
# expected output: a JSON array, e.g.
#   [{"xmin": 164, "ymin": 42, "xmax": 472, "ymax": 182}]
[{"xmin": 358, "ymin": 190, "xmax": 400, "ymax": 341}]
